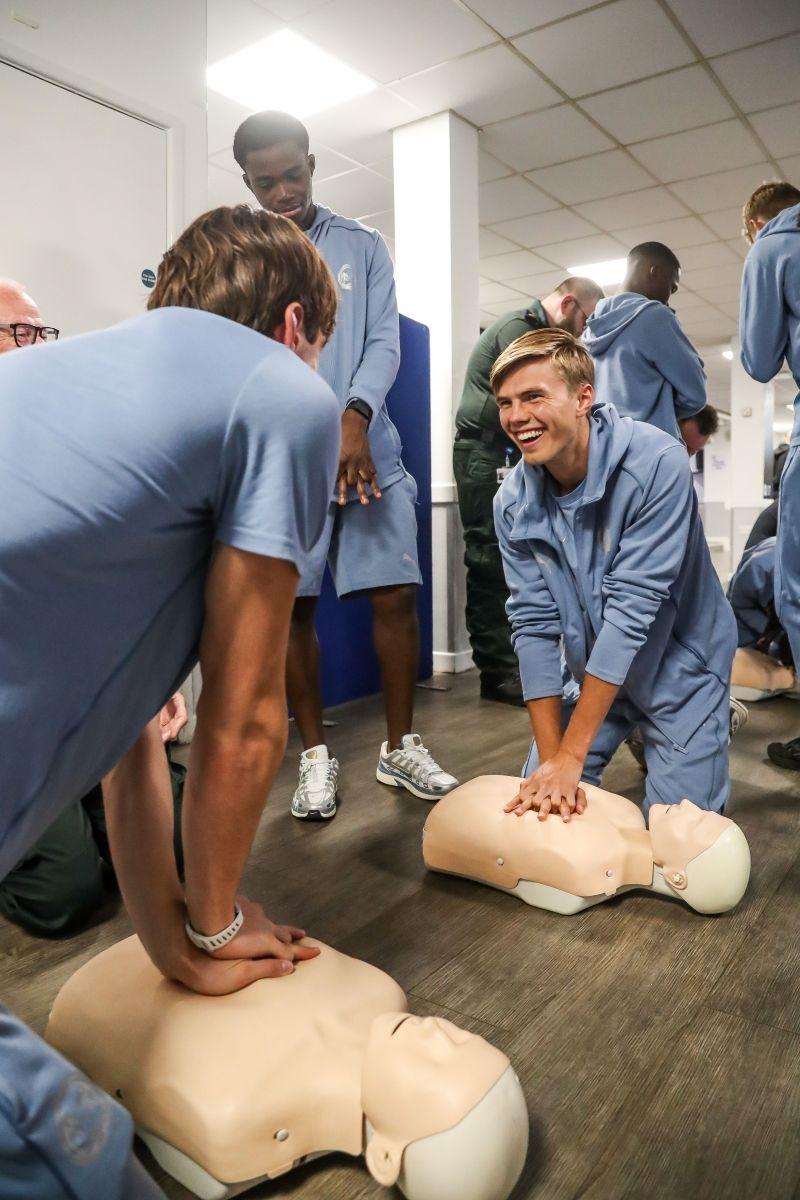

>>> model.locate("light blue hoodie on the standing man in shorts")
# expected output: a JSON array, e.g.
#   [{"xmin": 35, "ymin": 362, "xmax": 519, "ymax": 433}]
[{"xmin": 307, "ymin": 204, "xmax": 405, "ymax": 497}]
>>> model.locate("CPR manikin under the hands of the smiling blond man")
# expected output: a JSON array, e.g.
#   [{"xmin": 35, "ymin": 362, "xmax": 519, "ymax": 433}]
[{"xmin": 422, "ymin": 775, "xmax": 750, "ymax": 913}]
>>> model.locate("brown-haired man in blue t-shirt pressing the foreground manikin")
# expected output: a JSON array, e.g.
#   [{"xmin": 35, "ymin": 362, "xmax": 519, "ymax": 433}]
[{"xmin": 0, "ymin": 205, "xmax": 341, "ymax": 1200}]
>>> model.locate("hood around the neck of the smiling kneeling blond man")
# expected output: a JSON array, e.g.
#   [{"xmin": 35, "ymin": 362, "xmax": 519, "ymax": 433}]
[{"xmin": 504, "ymin": 403, "xmax": 633, "ymax": 540}]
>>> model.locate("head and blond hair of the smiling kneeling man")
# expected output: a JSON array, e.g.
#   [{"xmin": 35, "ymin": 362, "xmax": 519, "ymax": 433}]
[{"xmin": 489, "ymin": 329, "xmax": 595, "ymax": 490}]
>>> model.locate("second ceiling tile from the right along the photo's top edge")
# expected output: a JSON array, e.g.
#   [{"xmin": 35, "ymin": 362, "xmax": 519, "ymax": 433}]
[{"xmin": 515, "ymin": 0, "xmax": 694, "ymax": 95}]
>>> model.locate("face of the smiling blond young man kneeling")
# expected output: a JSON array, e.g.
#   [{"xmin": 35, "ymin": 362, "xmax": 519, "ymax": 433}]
[{"xmin": 495, "ymin": 359, "xmax": 594, "ymax": 467}]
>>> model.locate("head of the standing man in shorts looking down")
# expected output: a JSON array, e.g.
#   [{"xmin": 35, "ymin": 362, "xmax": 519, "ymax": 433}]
[{"xmin": 234, "ymin": 112, "xmax": 315, "ymax": 229}]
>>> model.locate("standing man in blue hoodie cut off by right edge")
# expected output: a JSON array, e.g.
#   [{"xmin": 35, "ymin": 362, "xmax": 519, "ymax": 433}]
[{"xmin": 739, "ymin": 182, "xmax": 800, "ymax": 770}]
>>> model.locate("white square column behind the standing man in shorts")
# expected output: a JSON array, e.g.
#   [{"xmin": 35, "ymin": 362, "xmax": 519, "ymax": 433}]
[{"xmin": 393, "ymin": 113, "xmax": 480, "ymax": 671}]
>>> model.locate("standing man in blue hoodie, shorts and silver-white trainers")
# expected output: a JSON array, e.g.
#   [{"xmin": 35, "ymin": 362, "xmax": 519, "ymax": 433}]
[{"xmin": 233, "ymin": 112, "xmax": 458, "ymax": 820}]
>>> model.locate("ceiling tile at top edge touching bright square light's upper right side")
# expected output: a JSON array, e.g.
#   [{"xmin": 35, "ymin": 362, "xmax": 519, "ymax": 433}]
[{"xmin": 291, "ymin": 0, "xmax": 495, "ymax": 84}]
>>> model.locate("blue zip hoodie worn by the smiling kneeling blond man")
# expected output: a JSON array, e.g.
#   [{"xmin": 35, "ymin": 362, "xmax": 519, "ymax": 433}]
[{"xmin": 494, "ymin": 403, "xmax": 736, "ymax": 749}]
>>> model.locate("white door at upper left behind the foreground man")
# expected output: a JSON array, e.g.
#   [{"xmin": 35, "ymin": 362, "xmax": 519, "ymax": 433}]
[{"xmin": 0, "ymin": 62, "xmax": 167, "ymax": 337}]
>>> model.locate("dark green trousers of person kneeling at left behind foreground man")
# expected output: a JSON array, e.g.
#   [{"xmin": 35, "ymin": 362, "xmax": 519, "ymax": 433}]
[{"xmin": 0, "ymin": 762, "xmax": 186, "ymax": 937}]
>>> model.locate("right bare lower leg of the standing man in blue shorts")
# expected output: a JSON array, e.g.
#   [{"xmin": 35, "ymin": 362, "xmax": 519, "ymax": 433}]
[{"xmin": 369, "ymin": 583, "xmax": 420, "ymax": 751}]
